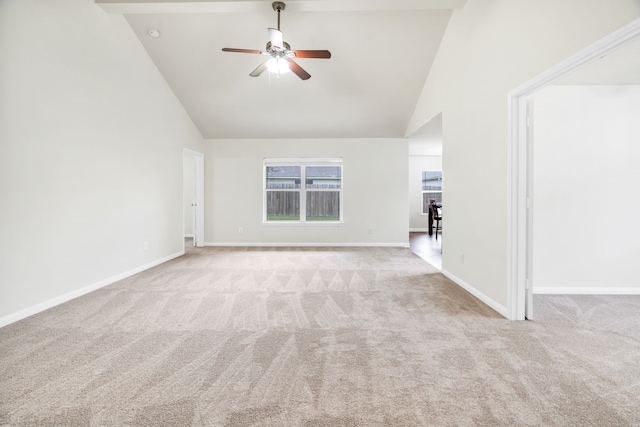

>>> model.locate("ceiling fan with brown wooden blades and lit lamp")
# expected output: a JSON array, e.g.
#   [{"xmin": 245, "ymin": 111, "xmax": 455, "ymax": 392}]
[{"xmin": 222, "ymin": 1, "xmax": 331, "ymax": 80}]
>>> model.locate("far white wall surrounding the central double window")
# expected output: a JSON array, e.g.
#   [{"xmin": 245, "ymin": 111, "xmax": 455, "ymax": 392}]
[{"xmin": 205, "ymin": 138, "xmax": 409, "ymax": 246}]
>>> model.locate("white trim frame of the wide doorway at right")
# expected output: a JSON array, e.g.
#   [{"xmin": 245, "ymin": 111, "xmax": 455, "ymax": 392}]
[{"xmin": 507, "ymin": 18, "xmax": 640, "ymax": 320}]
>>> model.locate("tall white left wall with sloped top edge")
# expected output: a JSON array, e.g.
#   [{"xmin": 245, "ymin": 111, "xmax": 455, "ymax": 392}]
[{"xmin": 0, "ymin": 0, "xmax": 202, "ymax": 324}]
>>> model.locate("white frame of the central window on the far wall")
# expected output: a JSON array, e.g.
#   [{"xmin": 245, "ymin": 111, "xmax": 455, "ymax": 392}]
[{"xmin": 262, "ymin": 158, "xmax": 344, "ymax": 227}]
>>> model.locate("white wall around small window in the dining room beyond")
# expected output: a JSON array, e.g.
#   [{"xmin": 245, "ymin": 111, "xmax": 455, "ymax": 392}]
[{"xmin": 409, "ymin": 156, "xmax": 442, "ymax": 231}]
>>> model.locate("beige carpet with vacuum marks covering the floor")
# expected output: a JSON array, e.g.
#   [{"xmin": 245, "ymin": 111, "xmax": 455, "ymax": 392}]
[{"xmin": 0, "ymin": 248, "xmax": 640, "ymax": 426}]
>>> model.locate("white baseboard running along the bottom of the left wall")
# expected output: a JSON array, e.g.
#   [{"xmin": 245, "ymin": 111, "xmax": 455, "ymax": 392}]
[{"xmin": 0, "ymin": 250, "xmax": 185, "ymax": 328}]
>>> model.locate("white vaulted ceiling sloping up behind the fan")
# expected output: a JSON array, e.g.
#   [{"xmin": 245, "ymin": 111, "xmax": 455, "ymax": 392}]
[{"xmin": 96, "ymin": 0, "xmax": 466, "ymax": 139}]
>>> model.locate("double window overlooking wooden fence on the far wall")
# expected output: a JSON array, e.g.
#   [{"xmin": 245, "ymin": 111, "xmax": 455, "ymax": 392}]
[{"xmin": 264, "ymin": 159, "xmax": 342, "ymax": 224}]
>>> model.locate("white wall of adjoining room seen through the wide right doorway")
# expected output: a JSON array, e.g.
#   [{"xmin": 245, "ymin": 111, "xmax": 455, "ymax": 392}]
[{"xmin": 533, "ymin": 86, "xmax": 640, "ymax": 293}]
